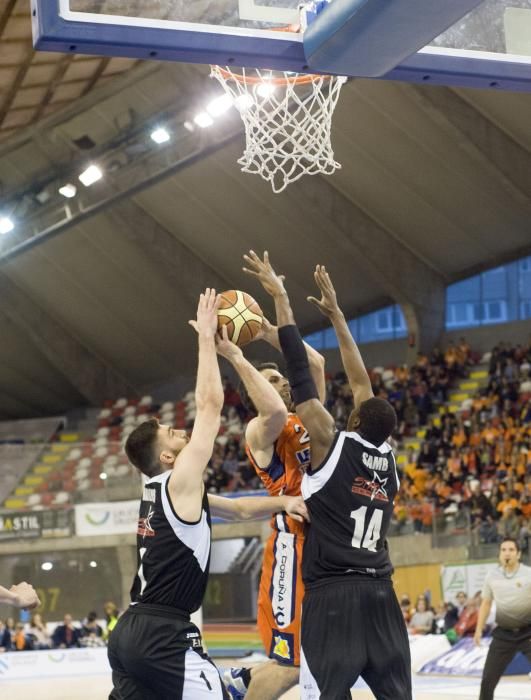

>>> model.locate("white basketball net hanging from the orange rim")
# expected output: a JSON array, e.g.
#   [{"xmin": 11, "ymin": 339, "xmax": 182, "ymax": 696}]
[{"xmin": 211, "ymin": 66, "xmax": 346, "ymax": 193}]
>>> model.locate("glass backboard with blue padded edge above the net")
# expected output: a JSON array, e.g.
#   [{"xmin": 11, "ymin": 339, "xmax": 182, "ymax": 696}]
[{"xmin": 32, "ymin": 0, "xmax": 531, "ymax": 91}]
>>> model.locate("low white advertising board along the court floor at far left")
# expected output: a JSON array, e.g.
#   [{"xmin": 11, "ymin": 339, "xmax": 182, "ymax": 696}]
[{"xmin": 0, "ymin": 648, "xmax": 111, "ymax": 680}]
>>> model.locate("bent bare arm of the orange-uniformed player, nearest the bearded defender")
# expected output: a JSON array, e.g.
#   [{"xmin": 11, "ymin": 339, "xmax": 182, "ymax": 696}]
[{"xmin": 217, "ymin": 326, "xmax": 288, "ymax": 454}]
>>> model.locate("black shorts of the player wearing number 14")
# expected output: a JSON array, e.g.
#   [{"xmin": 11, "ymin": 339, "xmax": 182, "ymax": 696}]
[{"xmin": 300, "ymin": 575, "xmax": 412, "ymax": 700}]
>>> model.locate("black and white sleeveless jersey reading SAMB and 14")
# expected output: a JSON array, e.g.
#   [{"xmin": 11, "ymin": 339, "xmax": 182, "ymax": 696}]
[{"xmin": 302, "ymin": 431, "xmax": 399, "ymax": 586}]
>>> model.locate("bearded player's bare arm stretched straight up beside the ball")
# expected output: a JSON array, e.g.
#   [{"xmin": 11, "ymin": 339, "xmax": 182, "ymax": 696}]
[{"xmin": 169, "ymin": 289, "xmax": 223, "ymax": 500}]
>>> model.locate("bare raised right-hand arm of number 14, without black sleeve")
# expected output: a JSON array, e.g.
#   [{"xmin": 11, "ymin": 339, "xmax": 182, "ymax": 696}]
[{"xmin": 308, "ymin": 265, "xmax": 374, "ymax": 408}]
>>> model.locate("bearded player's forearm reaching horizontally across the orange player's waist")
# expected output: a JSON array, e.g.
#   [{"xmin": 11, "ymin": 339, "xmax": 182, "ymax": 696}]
[{"xmin": 208, "ymin": 493, "xmax": 309, "ymax": 522}]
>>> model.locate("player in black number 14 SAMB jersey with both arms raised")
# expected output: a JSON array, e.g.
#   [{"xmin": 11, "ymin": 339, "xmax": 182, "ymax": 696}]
[{"xmin": 245, "ymin": 258, "xmax": 412, "ymax": 700}]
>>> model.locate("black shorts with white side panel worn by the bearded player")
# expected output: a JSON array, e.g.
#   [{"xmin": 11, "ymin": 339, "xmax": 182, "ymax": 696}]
[{"xmin": 108, "ymin": 605, "xmax": 229, "ymax": 700}]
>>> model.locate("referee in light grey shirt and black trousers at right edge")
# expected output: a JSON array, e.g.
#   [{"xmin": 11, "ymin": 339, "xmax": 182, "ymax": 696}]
[{"xmin": 474, "ymin": 537, "xmax": 531, "ymax": 700}]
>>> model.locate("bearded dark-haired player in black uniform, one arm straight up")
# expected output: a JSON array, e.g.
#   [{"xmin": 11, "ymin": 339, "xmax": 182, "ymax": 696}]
[{"xmin": 108, "ymin": 289, "xmax": 306, "ymax": 700}]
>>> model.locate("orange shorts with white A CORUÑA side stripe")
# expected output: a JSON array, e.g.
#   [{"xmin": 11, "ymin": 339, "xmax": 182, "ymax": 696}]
[{"xmin": 257, "ymin": 531, "xmax": 304, "ymax": 666}]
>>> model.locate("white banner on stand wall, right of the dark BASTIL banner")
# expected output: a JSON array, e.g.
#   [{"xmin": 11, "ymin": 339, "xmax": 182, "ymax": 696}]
[{"xmin": 75, "ymin": 500, "xmax": 139, "ymax": 537}]
